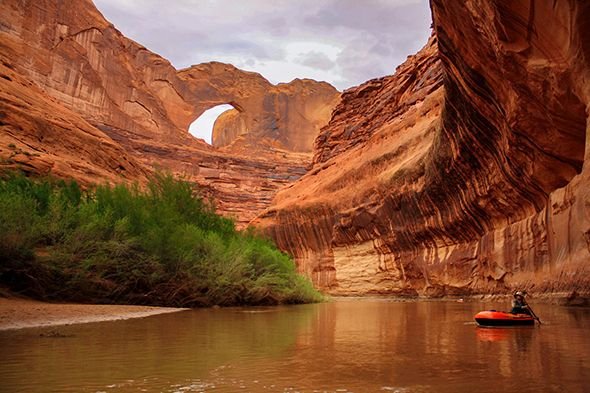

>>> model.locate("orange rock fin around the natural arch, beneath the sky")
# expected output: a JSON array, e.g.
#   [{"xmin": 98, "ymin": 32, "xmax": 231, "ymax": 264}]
[{"xmin": 178, "ymin": 62, "xmax": 340, "ymax": 153}]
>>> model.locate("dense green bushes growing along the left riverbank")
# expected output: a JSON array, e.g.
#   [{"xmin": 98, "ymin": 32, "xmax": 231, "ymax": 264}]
[{"xmin": 0, "ymin": 174, "xmax": 321, "ymax": 307}]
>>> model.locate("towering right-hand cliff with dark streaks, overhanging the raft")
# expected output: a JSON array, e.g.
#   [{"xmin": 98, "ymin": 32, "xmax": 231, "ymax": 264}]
[{"xmin": 256, "ymin": 0, "xmax": 590, "ymax": 296}]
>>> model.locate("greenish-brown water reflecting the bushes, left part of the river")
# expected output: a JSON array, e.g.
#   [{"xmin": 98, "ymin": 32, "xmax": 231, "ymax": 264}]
[{"xmin": 0, "ymin": 307, "xmax": 314, "ymax": 392}]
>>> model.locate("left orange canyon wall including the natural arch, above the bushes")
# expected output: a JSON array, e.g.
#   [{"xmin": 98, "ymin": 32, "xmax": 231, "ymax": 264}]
[{"xmin": 0, "ymin": 0, "xmax": 339, "ymax": 225}]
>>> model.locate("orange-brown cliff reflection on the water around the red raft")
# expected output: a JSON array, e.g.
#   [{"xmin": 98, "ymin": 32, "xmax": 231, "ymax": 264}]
[{"xmin": 288, "ymin": 301, "xmax": 590, "ymax": 392}]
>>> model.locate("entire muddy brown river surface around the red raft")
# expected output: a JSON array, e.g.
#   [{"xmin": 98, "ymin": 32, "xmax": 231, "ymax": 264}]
[{"xmin": 0, "ymin": 299, "xmax": 590, "ymax": 393}]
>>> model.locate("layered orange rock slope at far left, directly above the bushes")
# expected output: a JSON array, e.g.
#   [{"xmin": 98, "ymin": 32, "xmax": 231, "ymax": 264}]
[{"xmin": 0, "ymin": 59, "xmax": 147, "ymax": 185}]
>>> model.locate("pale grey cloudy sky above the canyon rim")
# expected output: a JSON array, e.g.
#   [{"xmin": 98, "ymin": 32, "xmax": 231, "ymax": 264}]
[{"xmin": 94, "ymin": 0, "xmax": 431, "ymax": 90}]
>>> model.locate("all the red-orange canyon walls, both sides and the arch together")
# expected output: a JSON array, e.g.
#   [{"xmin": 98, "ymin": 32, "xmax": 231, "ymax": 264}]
[{"xmin": 0, "ymin": 0, "xmax": 590, "ymax": 304}]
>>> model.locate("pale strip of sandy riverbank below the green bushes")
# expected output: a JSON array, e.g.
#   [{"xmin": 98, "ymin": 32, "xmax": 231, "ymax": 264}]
[{"xmin": 0, "ymin": 297, "xmax": 187, "ymax": 330}]
